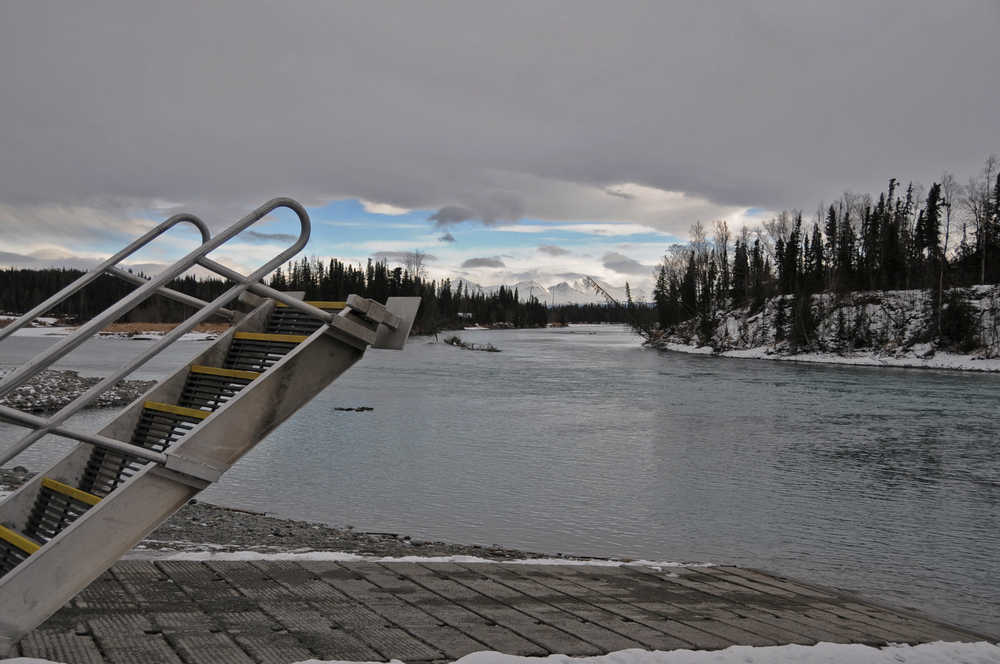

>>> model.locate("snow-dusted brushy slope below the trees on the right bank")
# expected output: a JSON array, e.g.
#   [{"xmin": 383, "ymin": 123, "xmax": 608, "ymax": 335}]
[{"xmin": 648, "ymin": 286, "xmax": 1000, "ymax": 371}]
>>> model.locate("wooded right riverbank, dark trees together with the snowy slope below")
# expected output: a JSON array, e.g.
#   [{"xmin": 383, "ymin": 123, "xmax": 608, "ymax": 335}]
[{"xmin": 628, "ymin": 156, "xmax": 1000, "ymax": 357}]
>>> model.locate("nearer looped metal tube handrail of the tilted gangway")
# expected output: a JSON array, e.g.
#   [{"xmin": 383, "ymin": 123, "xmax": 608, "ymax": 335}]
[{"xmin": 0, "ymin": 198, "xmax": 312, "ymax": 465}]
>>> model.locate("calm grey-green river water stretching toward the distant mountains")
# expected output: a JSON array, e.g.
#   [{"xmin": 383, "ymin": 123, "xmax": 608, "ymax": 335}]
[{"xmin": 0, "ymin": 326, "xmax": 1000, "ymax": 634}]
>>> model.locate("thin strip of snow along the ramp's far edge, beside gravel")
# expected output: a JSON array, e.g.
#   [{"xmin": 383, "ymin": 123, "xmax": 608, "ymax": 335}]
[{"xmin": 125, "ymin": 543, "xmax": 715, "ymax": 570}]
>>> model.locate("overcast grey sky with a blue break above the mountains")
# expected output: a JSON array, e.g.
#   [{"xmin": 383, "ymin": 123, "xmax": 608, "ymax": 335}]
[{"xmin": 0, "ymin": 0, "xmax": 1000, "ymax": 285}]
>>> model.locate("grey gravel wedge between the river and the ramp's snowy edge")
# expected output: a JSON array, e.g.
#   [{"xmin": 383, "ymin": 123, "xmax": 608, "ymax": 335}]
[{"xmin": 0, "ymin": 466, "xmax": 556, "ymax": 560}]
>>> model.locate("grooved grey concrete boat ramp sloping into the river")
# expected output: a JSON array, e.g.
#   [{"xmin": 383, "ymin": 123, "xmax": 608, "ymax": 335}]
[{"xmin": 12, "ymin": 559, "xmax": 996, "ymax": 664}]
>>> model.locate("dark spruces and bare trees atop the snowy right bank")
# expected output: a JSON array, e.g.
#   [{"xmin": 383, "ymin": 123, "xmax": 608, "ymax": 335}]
[{"xmin": 644, "ymin": 156, "xmax": 1000, "ymax": 349}]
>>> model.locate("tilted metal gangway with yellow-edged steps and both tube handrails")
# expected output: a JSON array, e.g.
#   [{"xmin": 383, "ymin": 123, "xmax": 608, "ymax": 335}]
[{"xmin": 0, "ymin": 198, "xmax": 420, "ymax": 656}]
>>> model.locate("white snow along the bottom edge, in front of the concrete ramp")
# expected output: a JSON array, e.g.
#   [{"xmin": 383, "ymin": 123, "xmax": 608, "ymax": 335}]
[{"xmin": 7, "ymin": 641, "xmax": 1000, "ymax": 664}]
